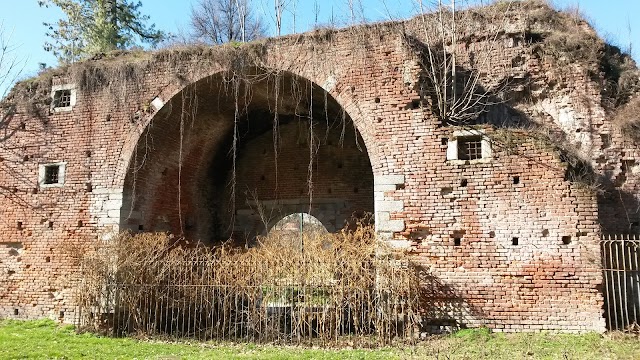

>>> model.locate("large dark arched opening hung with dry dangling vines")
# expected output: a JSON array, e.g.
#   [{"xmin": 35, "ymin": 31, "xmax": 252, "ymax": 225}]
[{"xmin": 120, "ymin": 71, "xmax": 374, "ymax": 244}]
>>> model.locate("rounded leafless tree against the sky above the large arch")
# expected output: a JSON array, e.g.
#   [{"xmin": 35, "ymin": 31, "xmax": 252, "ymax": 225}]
[{"xmin": 190, "ymin": 0, "xmax": 266, "ymax": 44}]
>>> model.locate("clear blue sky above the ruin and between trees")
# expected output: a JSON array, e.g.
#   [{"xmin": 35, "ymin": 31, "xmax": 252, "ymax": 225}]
[{"xmin": 0, "ymin": 0, "xmax": 640, "ymax": 95}]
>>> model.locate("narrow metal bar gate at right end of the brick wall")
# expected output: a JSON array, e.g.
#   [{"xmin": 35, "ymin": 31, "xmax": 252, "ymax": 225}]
[{"xmin": 600, "ymin": 235, "xmax": 640, "ymax": 330}]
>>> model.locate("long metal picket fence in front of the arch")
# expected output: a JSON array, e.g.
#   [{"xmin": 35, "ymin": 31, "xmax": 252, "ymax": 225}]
[{"xmin": 78, "ymin": 260, "xmax": 417, "ymax": 346}]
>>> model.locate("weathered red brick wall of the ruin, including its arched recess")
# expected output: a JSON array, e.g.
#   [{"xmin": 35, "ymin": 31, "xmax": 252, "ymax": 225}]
[{"xmin": 0, "ymin": 1, "xmax": 640, "ymax": 331}]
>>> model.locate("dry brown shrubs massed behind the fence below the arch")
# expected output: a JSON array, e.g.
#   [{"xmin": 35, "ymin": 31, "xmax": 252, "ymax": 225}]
[{"xmin": 78, "ymin": 226, "xmax": 421, "ymax": 344}]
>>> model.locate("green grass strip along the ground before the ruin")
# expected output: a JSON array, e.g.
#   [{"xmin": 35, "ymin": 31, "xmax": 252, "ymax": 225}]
[{"xmin": 0, "ymin": 320, "xmax": 640, "ymax": 360}]
